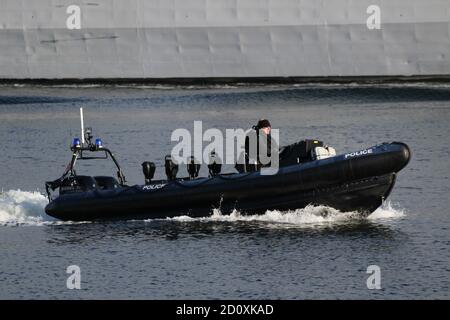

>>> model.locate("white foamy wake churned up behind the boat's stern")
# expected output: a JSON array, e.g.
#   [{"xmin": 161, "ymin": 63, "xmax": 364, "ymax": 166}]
[{"xmin": 0, "ymin": 190, "xmax": 55, "ymax": 226}]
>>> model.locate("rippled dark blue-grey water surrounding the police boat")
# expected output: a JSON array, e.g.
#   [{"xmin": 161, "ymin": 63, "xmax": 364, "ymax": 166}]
[{"xmin": 0, "ymin": 83, "xmax": 450, "ymax": 299}]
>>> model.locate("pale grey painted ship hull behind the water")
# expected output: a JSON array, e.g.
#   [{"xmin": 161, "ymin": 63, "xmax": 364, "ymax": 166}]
[{"xmin": 0, "ymin": 0, "xmax": 450, "ymax": 80}]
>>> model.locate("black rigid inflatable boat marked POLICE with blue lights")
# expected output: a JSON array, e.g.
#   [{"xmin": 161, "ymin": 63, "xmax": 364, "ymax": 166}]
[{"xmin": 45, "ymin": 129, "xmax": 411, "ymax": 221}]
